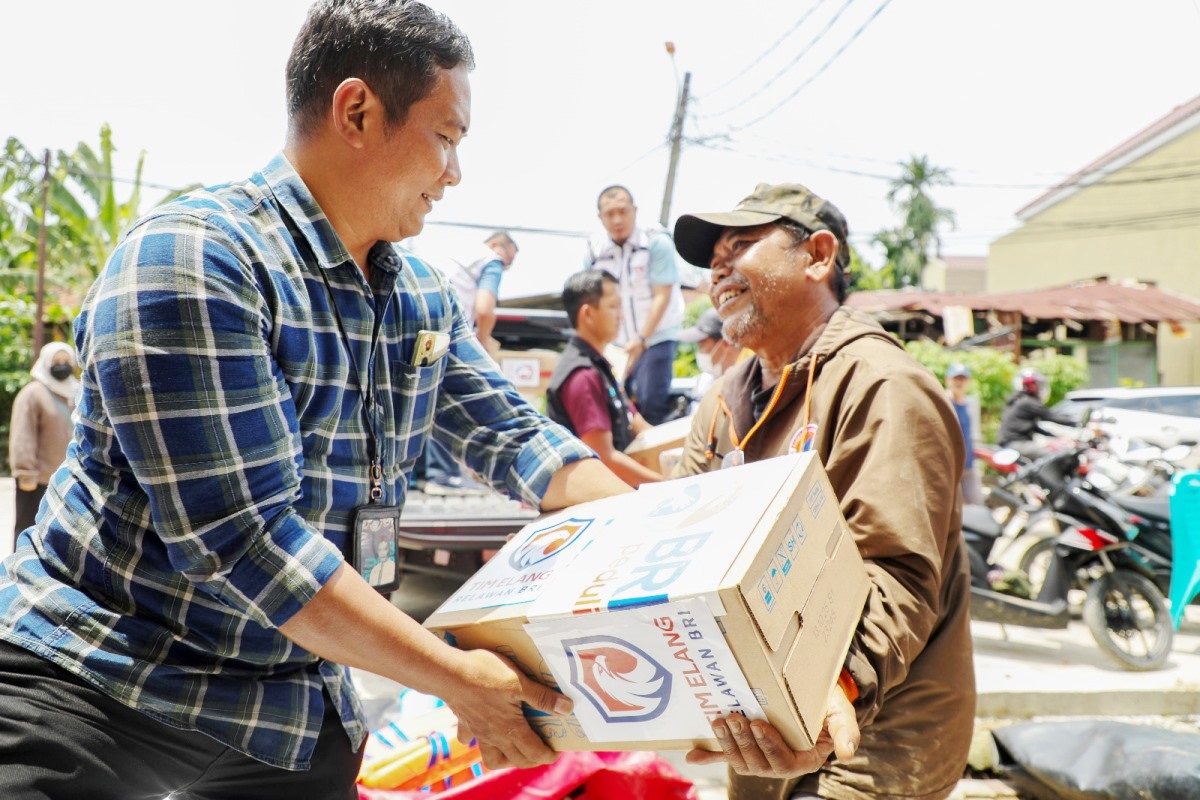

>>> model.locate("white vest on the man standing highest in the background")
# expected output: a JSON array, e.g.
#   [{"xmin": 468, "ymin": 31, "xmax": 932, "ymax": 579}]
[{"xmin": 588, "ymin": 228, "xmax": 684, "ymax": 345}]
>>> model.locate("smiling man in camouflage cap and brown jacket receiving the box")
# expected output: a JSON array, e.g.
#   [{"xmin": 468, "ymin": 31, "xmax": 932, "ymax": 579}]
[{"xmin": 674, "ymin": 184, "xmax": 974, "ymax": 800}]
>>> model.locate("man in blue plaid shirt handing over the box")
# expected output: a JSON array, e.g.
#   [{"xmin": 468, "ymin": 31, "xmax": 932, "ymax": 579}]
[{"xmin": 0, "ymin": 0, "xmax": 629, "ymax": 799}]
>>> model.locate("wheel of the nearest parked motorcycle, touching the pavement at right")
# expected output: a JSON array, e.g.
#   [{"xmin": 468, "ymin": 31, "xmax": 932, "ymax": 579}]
[{"xmin": 1084, "ymin": 570, "xmax": 1175, "ymax": 670}]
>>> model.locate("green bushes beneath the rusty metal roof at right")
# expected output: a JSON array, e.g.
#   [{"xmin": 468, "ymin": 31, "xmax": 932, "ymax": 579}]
[{"xmin": 905, "ymin": 339, "xmax": 1087, "ymax": 441}]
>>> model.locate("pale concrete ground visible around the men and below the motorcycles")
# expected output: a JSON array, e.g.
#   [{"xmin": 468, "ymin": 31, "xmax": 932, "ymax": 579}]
[{"xmin": 0, "ymin": 477, "xmax": 1200, "ymax": 800}]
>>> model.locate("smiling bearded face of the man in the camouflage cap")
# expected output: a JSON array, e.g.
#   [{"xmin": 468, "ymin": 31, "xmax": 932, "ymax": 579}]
[{"xmin": 709, "ymin": 223, "xmax": 812, "ymax": 350}]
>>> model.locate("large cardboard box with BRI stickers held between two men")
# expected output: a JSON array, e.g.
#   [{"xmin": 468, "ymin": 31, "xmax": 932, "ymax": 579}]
[{"xmin": 426, "ymin": 453, "xmax": 868, "ymax": 751}]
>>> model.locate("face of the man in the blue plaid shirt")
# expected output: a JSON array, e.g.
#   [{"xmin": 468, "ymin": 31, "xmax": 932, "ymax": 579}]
[{"xmin": 365, "ymin": 65, "xmax": 470, "ymax": 241}]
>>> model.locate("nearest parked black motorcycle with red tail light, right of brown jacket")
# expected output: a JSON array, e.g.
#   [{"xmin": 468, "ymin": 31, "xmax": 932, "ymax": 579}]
[{"xmin": 962, "ymin": 444, "xmax": 1174, "ymax": 669}]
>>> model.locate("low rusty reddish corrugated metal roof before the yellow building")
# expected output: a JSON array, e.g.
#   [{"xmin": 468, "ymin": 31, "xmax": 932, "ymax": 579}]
[{"xmin": 846, "ymin": 281, "xmax": 1200, "ymax": 323}]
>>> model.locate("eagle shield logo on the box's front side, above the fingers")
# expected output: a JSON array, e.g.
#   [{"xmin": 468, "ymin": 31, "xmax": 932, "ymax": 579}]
[{"xmin": 563, "ymin": 634, "xmax": 671, "ymax": 722}]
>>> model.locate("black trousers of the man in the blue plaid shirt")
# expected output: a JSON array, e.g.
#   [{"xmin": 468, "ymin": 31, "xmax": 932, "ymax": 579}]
[{"xmin": 0, "ymin": 642, "xmax": 362, "ymax": 800}]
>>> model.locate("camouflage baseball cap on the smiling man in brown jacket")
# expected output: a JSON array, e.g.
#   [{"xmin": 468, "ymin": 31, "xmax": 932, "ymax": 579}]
[{"xmin": 674, "ymin": 184, "xmax": 850, "ymax": 269}]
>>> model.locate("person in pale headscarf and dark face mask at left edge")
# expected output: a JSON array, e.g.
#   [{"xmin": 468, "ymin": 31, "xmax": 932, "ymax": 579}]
[{"xmin": 8, "ymin": 342, "xmax": 79, "ymax": 533}]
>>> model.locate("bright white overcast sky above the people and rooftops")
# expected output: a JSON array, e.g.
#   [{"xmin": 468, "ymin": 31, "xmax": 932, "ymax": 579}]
[{"xmin": 0, "ymin": 0, "xmax": 1200, "ymax": 297}]
